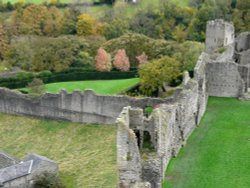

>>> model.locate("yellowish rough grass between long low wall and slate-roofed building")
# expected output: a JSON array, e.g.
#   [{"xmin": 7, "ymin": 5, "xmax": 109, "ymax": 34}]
[{"xmin": 0, "ymin": 114, "xmax": 117, "ymax": 188}]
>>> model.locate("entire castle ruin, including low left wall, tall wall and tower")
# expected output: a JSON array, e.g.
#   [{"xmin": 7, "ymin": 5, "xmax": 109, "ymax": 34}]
[{"xmin": 0, "ymin": 20, "xmax": 250, "ymax": 188}]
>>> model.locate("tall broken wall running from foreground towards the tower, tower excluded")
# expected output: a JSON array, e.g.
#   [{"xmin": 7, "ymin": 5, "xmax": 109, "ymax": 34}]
[{"xmin": 117, "ymin": 54, "xmax": 208, "ymax": 188}]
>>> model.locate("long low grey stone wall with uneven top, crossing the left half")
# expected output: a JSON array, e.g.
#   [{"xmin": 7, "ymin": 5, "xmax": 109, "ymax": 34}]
[{"xmin": 0, "ymin": 88, "xmax": 164, "ymax": 124}]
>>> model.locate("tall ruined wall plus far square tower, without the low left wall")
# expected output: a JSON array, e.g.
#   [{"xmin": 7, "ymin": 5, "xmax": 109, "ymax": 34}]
[{"xmin": 117, "ymin": 20, "xmax": 250, "ymax": 188}]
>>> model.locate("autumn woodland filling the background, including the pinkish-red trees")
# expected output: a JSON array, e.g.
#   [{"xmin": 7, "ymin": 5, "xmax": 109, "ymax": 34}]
[{"xmin": 0, "ymin": 0, "xmax": 250, "ymax": 95}]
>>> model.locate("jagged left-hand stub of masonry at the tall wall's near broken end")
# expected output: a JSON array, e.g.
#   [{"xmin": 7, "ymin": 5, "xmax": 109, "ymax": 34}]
[{"xmin": 116, "ymin": 107, "xmax": 150, "ymax": 188}]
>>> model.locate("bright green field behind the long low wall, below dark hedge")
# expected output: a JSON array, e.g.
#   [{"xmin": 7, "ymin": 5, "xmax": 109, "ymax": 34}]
[{"xmin": 21, "ymin": 78, "xmax": 139, "ymax": 95}]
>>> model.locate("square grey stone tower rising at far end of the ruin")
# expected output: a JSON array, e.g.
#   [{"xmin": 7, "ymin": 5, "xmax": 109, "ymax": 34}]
[{"xmin": 205, "ymin": 19, "xmax": 234, "ymax": 54}]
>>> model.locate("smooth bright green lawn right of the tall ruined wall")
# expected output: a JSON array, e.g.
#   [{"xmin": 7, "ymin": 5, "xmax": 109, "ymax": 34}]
[{"xmin": 164, "ymin": 97, "xmax": 250, "ymax": 188}]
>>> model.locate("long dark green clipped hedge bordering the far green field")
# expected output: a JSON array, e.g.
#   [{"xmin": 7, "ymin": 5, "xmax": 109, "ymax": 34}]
[{"xmin": 0, "ymin": 69, "xmax": 137, "ymax": 89}]
